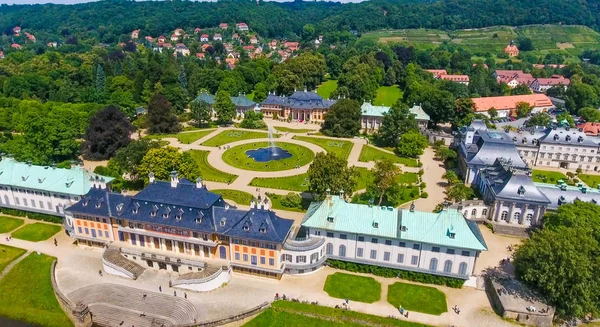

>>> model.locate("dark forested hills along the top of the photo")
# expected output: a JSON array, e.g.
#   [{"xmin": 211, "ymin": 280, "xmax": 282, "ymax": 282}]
[{"xmin": 0, "ymin": 0, "xmax": 600, "ymax": 43}]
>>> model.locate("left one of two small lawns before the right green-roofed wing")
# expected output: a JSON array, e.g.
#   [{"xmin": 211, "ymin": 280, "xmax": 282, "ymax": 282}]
[{"xmin": 323, "ymin": 273, "xmax": 381, "ymax": 303}]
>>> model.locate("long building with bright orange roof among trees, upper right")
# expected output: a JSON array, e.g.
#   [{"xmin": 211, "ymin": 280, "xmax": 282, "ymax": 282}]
[{"xmin": 471, "ymin": 94, "xmax": 554, "ymax": 117}]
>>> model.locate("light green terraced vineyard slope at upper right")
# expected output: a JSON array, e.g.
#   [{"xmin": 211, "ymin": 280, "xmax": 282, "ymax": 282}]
[{"xmin": 362, "ymin": 25, "xmax": 600, "ymax": 56}]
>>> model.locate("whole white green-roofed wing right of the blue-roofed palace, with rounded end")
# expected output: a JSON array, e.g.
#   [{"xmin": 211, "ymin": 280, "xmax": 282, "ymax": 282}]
[{"xmin": 282, "ymin": 195, "xmax": 487, "ymax": 280}]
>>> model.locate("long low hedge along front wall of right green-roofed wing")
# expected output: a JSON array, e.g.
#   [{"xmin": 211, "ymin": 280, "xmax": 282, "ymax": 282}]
[{"xmin": 327, "ymin": 259, "xmax": 465, "ymax": 288}]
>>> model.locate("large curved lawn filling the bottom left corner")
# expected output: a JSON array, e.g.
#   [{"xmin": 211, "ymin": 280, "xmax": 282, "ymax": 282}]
[{"xmin": 0, "ymin": 252, "xmax": 73, "ymax": 327}]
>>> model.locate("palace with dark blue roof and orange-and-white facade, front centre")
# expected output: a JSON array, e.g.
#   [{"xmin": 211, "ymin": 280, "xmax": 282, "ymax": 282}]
[{"xmin": 66, "ymin": 172, "xmax": 293, "ymax": 278}]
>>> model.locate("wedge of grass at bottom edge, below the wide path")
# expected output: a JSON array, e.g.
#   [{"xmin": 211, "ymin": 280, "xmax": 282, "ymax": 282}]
[{"xmin": 244, "ymin": 301, "xmax": 431, "ymax": 327}]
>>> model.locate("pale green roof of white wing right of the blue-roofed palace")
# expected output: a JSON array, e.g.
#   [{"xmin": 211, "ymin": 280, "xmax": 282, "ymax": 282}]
[{"xmin": 302, "ymin": 196, "xmax": 487, "ymax": 250}]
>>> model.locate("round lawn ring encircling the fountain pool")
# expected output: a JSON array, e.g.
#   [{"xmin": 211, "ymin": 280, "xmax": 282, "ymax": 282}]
[{"xmin": 222, "ymin": 142, "xmax": 315, "ymax": 171}]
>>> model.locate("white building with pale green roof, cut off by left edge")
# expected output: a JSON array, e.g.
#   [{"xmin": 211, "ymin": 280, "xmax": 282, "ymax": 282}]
[{"xmin": 0, "ymin": 157, "xmax": 113, "ymax": 216}]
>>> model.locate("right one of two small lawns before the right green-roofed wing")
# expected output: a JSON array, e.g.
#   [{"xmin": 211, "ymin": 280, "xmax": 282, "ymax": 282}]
[{"xmin": 387, "ymin": 282, "xmax": 448, "ymax": 316}]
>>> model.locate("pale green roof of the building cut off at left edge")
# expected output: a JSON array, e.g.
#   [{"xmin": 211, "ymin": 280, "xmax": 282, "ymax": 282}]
[{"xmin": 0, "ymin": 158, "xmax": 114, "ymax": 196}]
